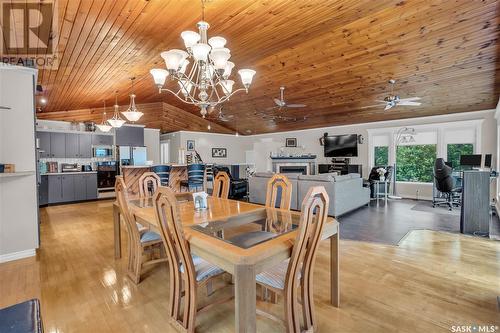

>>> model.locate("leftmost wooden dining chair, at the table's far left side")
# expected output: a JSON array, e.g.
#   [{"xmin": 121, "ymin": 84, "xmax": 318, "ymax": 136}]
[{"xmin": 115, "ymin": 176, "xmax": 167, "ymax": 284}]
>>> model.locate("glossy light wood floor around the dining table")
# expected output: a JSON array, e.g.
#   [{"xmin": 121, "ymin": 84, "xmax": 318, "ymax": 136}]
[{"xmin": 0, "ymin": 201, "xmax": 500, "ymax": 333}]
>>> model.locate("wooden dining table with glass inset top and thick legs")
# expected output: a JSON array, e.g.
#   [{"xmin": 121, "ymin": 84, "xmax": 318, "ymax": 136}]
[{"xmin": 115, "ymin": 197, "xmax": 340, "ymax": 332}]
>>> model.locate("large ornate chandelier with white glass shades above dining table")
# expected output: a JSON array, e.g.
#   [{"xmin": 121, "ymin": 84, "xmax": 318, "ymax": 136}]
[{"xmin": 150, "ymin": 0, "xmax": 255, "ymax": 118}]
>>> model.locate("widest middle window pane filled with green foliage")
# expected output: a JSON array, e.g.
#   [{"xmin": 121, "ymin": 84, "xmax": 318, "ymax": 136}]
[{"xmin": 396, "ymin": 144, "xmax": 436, "ymax": 183}]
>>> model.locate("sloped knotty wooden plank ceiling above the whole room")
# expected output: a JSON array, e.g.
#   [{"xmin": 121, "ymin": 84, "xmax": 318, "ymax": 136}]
[{"xmin": 33, "ymin": 0, "xmax": 500, "ymax": 134}]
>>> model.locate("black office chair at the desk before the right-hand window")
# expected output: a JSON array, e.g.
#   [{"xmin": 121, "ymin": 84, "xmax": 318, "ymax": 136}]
[{"xmin": 432, "ymin": 158, "xmax": 462, "ymax": 210}]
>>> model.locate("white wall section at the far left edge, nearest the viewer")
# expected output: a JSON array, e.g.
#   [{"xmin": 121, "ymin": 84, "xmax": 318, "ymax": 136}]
[{"xmin": 0, "ymin": 66, "xmax": 38, "ymax": 262}]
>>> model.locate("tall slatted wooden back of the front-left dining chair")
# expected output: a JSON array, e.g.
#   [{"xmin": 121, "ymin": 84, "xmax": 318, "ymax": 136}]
[{"xmin": 153, "ymin": 187, "xmax": 196, "ymax": 327}]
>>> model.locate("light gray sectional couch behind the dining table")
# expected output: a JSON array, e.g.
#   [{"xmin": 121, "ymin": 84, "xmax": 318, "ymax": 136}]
[{"xmin": 249, "ymin": 172, "xmax": 370, "ymax": 216}]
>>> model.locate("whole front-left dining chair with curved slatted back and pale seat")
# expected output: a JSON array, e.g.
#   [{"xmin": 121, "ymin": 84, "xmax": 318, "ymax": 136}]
[{"xmin": 153, "ymin": 187, "xmax": 233, "ymax": 333}]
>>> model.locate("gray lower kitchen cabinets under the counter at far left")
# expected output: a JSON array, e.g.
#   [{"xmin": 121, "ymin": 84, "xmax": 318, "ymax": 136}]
[{"xmin": 46, "ymin": 173, "xmax": 97, "ymax": 204}]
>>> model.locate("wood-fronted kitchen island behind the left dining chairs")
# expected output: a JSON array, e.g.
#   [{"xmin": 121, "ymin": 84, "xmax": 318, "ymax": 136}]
[{"xmin": 121, "ymin": 164, "xmax": 187, "ymax": 196}]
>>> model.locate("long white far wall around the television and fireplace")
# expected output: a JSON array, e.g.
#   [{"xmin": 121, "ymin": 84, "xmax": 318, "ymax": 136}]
[{"xmin": 162, "ymin": 110, "xmax": 500, "ymax": 199}]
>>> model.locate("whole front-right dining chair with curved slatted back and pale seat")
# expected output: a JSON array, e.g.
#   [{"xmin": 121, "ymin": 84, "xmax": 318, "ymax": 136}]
[{"xmin": 255, "ymin": 186, "xmax": 330, "ymax": 333}]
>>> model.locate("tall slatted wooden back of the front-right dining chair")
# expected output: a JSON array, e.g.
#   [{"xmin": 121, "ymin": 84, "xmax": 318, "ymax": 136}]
[{"xmin": 284, "ymin": 186, "xmax": 330, "ymax": 332}]
